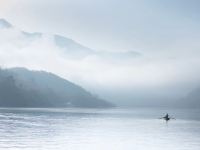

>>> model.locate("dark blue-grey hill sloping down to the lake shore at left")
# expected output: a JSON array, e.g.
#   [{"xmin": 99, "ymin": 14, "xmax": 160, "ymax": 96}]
[{"xmin": 0, "ymin": 68, "xmax": 113, "ymax": 108}]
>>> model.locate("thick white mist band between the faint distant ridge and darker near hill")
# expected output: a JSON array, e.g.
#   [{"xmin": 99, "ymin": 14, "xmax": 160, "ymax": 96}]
[{"xmin": 0, "ymin": 25, "xmax": 200, "ymax": 91}]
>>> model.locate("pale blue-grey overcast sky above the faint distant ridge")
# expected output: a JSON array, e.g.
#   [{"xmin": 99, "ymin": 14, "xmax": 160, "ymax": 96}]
[{"xmin": 0, "ymin": 0, "xmax": 200, "ymax": 52}]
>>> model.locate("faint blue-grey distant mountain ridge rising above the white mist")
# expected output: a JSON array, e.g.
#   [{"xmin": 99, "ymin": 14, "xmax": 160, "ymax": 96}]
[{"xmin": 0, "ymin": 19, "xmax": 140, "ymax": 59}]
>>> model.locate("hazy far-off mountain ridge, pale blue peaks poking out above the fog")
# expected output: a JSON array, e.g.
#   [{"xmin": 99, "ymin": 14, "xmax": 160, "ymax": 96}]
[{"xmin": 0, "ymin": 19, "xmax": 140, "ymax": 59}]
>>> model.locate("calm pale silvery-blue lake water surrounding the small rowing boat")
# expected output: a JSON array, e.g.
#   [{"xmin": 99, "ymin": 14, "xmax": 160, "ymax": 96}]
[{"xmin": 0, "ymin": 108, "xmax": 200, "ymax": 150}]
